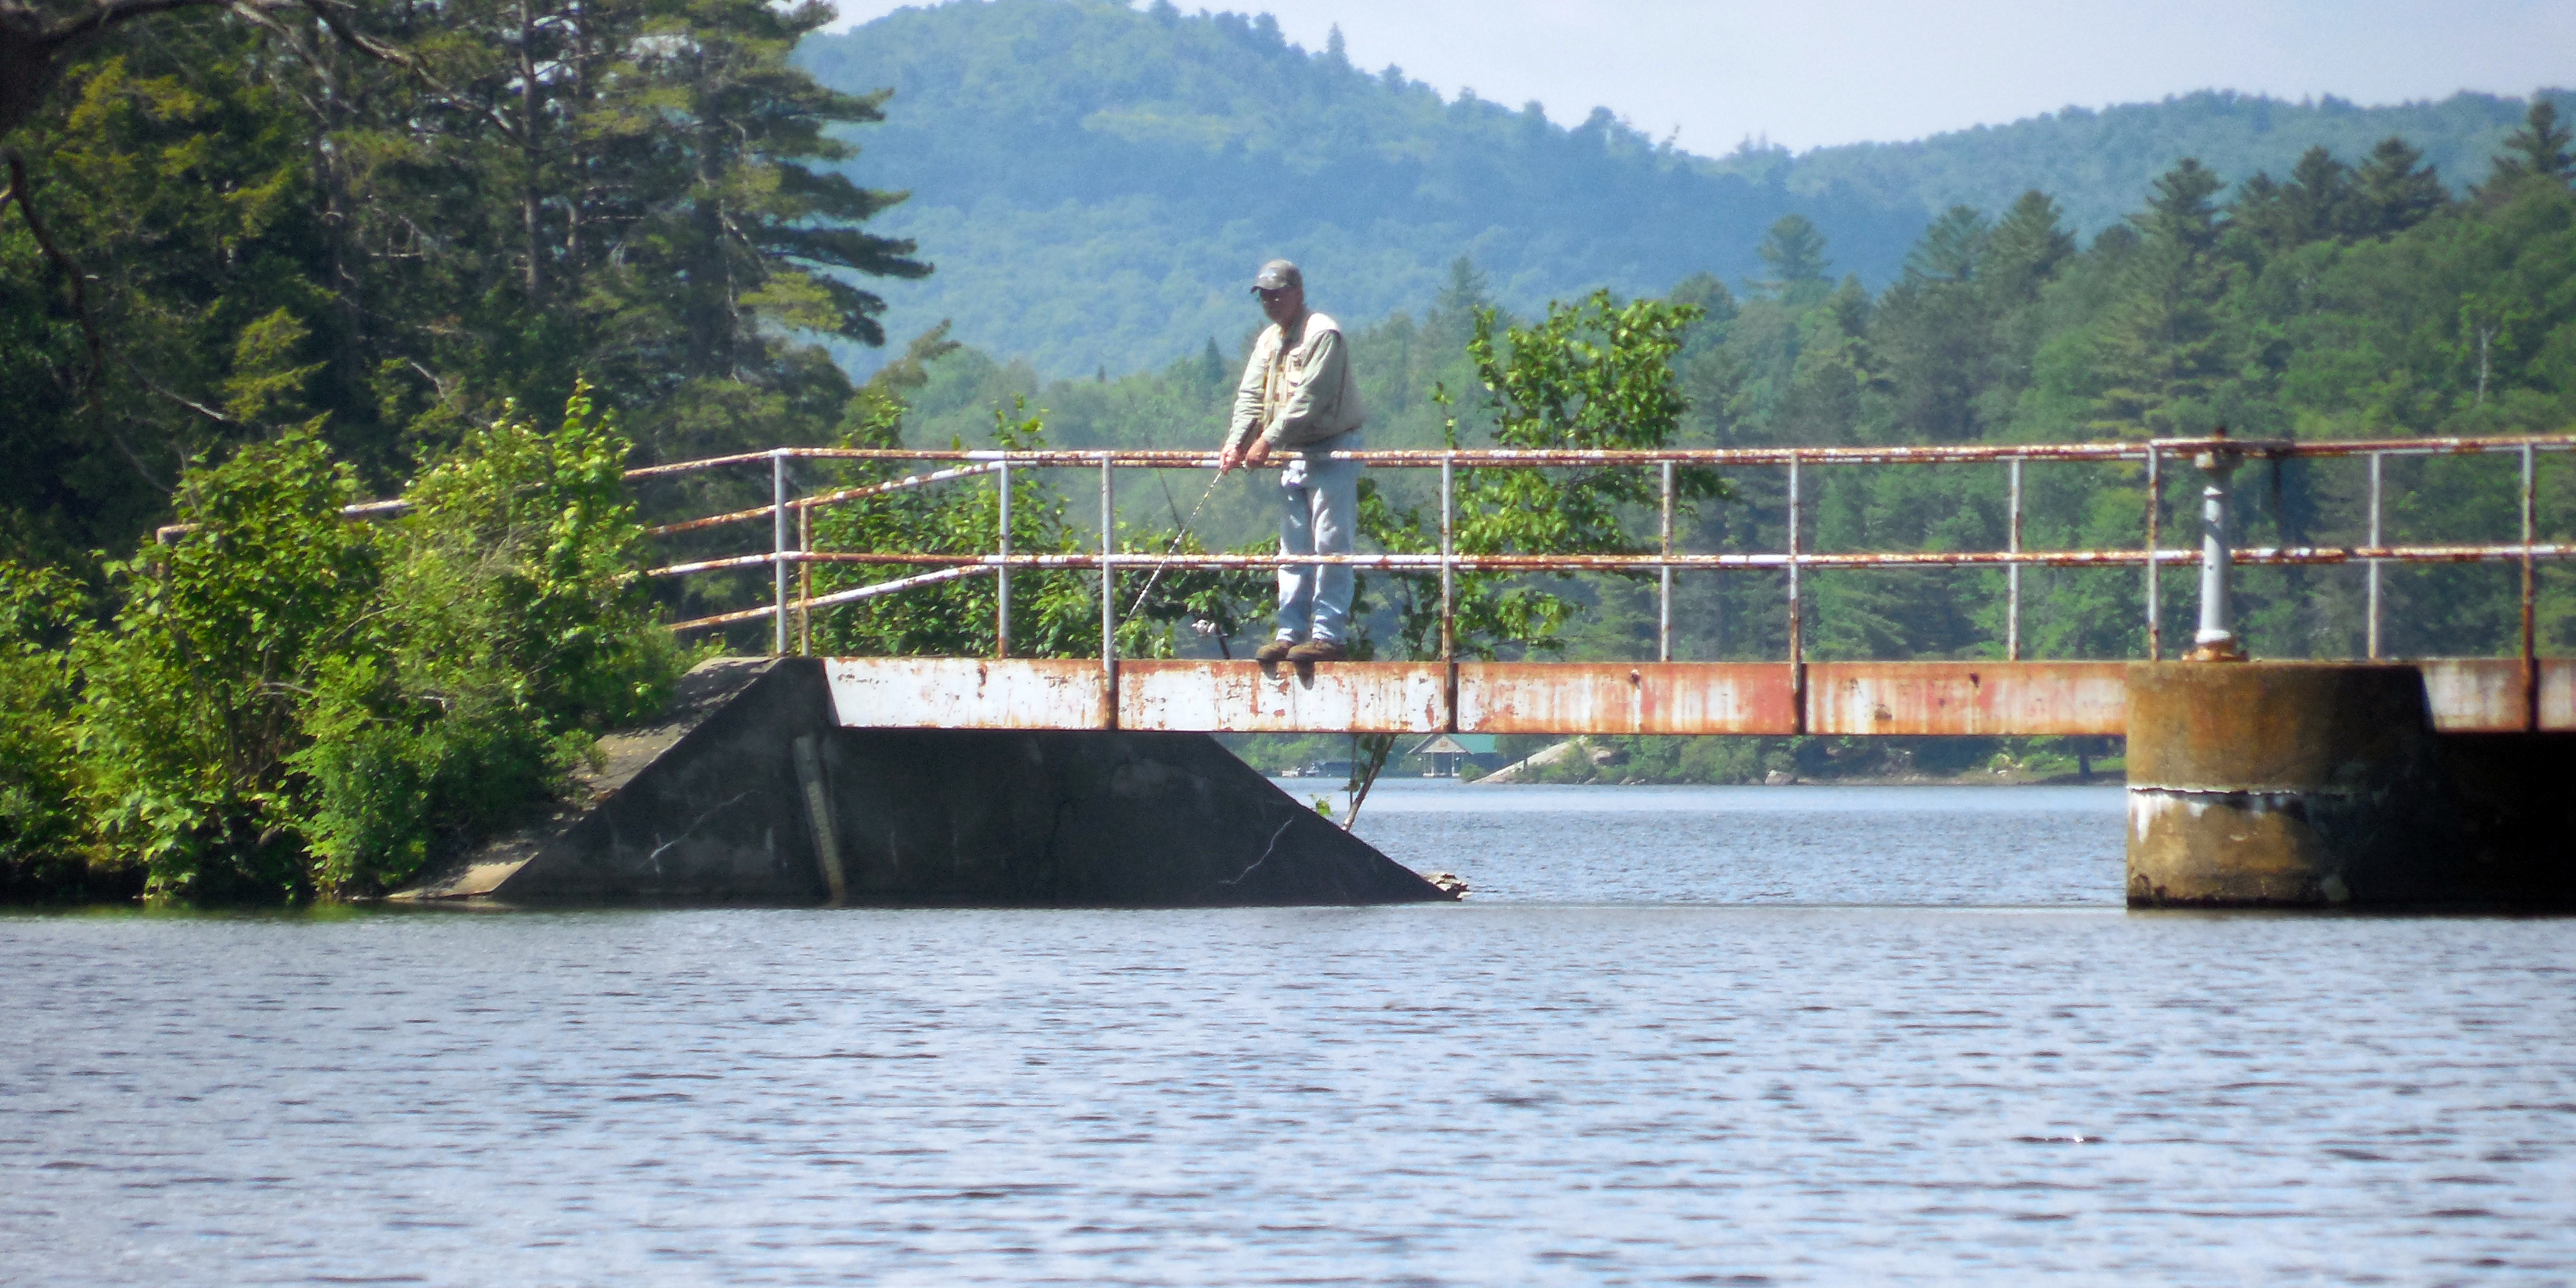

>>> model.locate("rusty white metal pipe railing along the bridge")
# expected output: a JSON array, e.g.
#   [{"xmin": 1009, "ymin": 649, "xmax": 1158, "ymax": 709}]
[{"xmin": 626, "ymin": 433, "xmax": 2576, "ymax": 695}]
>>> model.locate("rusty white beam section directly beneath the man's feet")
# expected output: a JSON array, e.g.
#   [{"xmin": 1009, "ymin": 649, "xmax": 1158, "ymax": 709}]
[{"xmin": 1118, "ymin": 660, "xmax": 1448, "ymax": 734}]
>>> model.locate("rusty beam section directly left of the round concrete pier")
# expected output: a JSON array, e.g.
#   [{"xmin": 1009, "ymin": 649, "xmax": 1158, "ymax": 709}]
[{"xmin": 1806, "ymin": 662, "xmax": 2128, "ymax": 734}]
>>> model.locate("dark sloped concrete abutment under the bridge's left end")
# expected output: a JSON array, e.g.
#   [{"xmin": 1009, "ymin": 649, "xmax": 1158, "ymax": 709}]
[{"xmin": 402, "ymin": 660, "xmax": 1448, "ymax": 907}]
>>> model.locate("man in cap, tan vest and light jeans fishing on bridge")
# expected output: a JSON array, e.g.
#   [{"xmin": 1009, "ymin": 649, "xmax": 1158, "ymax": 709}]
[{"xmin": 1216, "ymin": 260, "xmax": 1365, "ymax": 662}]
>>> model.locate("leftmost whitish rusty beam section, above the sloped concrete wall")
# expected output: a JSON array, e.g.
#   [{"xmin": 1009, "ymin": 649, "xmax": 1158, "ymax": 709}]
[{"xmin": 825, "ymin": 657, "xmax": 1107, "ymax": 729}]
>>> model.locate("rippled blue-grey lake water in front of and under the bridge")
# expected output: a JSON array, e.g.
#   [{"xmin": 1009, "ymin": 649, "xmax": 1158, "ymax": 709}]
[{"xmin": 0, "ymin": 783, "xmax": 2576, "ymax": 1285}]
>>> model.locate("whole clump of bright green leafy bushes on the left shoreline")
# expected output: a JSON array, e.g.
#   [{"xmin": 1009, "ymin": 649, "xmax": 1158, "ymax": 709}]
[{"xmin": 48, "ymin": 391, "xmax": 680, "ymax": 902}]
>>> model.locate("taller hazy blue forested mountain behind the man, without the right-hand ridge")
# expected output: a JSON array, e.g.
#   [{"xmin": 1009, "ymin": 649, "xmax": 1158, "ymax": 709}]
[{"xmin": 798, "ymin": 0, "xmax": 1922, "ymax": 373}]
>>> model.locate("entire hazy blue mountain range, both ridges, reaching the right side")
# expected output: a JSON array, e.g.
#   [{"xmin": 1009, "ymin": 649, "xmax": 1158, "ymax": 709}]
[{"xmin": 796, "ymin": 0, "xmax": 2565, "ymax": 376}]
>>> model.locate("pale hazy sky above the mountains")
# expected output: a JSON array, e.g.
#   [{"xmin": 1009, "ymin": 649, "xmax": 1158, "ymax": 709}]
[{"xmin": 819, "ymin": 0, "xmax": 2576, "ymax": 154}]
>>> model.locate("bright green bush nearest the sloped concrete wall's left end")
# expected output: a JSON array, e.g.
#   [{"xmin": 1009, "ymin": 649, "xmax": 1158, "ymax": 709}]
[{"xmin": 291, "ymin": 386, "xmax": 680, "ymax": 894}]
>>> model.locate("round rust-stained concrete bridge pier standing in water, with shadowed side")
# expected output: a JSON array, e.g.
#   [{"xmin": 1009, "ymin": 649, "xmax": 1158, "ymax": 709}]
[{"xmin": 2128, "ymin": 662, "xmax": 2576, "ymax": 907}]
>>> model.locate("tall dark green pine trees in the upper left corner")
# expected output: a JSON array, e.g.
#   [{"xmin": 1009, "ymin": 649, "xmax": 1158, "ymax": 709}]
[{"xmin": 0, "ymin": 0, "xmax": 930, "ymax": 574}]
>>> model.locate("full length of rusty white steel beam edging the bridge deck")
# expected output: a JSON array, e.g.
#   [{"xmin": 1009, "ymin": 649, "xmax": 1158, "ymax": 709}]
[{"xmin": 827, "ymin": 657, "xmax": 2576, "ymax": 734}]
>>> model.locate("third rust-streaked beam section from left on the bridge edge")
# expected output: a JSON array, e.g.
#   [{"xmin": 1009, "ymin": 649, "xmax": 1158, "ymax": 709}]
[{"xmin": 1458, "ymin": 662, "xmax": 1798, "ymax": 734}]
